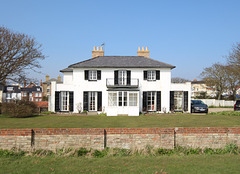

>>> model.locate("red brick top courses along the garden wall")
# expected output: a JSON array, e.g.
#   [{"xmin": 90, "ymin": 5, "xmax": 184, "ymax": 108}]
[{"xmin": 0, "ymin": 127, "xmax": 240, "ymax": 136}]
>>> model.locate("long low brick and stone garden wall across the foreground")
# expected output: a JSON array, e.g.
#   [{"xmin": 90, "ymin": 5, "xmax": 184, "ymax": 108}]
[{"xmin": 0, "ymin": 128, "xmax": 240, "ymax": 150}]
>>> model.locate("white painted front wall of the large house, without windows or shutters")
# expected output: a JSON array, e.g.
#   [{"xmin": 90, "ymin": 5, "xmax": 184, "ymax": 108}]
[{"xmin": 51, "ymin": 68, "xmax": 191, "ymax": 115}]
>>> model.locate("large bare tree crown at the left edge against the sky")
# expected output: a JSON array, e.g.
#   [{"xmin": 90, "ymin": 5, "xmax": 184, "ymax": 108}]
[{"xmin": 0, "ymin": 26, "xmax": 45, "ymax": 84}]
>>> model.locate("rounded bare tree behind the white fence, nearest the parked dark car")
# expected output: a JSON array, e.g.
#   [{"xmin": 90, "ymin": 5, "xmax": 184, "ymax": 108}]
[{"xmin": 201, "ymin": 63, "xmax": 227, "ymax": 100}]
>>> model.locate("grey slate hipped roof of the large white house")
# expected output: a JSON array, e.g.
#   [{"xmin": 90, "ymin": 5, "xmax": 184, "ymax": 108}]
[{"xmin": 61, "ymin": 56, "xmax": 175, "ymax": 72}]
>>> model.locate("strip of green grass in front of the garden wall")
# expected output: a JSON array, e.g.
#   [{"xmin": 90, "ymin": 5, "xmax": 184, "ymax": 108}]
[{"xmin": 0, "ymin": 154, "xmax": 240, "ymax": 174}]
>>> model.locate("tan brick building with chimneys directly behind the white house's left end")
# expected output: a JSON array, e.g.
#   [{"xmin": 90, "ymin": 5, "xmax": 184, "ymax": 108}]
[{"xmin": 41, "ymin": 75, "xmax": 62, "ymax": 97}]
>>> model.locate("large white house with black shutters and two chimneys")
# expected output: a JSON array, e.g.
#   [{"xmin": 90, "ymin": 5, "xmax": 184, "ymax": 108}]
[{"xmin": 49, "ymin": 47, "xmax": 191, "ymax": 116}]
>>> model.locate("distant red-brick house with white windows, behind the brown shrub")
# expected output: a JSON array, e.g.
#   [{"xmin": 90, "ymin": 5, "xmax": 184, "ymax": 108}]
[{"xmin": 21, "ymin": 82, "xmax": 43, "ymax": 102}]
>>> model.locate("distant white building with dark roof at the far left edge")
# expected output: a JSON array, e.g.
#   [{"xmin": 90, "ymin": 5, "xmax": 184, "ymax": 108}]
[{"xmin": 2, "ymin": 84, "xmax": 21, "ymax": 102}]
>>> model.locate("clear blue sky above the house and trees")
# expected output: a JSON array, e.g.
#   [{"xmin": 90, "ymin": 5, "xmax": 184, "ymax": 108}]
[{"xmin": 0, "ymin": 0, "xmax": 240, "ymax": 80}]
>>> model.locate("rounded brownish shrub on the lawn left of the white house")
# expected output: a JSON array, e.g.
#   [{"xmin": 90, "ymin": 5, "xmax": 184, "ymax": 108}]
[{"xmin": 2, "ymin": 100, "xmax": 38, "ymax": 118}]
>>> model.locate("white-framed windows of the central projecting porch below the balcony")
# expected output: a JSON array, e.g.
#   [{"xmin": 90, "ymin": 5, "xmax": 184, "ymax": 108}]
[{"xmin": 108, "ymin": 91, "xmax": 138, "ymax": 107}]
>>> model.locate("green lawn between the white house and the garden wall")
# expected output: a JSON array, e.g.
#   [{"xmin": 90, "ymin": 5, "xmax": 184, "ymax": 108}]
[{"xmin": 0, "ymin": 114, "xmax": 240, "ymax": 129}]
